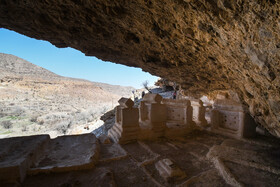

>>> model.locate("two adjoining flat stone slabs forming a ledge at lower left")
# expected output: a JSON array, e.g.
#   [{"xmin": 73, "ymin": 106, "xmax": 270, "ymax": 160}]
[{"xmin": 0, "ymin": 133, "xmax": 100, "ymax": 186}]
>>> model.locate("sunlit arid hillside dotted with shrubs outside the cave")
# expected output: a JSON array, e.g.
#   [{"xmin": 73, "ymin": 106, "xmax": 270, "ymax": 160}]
[{"xmin": 0, "ymin": 54, "xmax": 133, "ymax": 137}]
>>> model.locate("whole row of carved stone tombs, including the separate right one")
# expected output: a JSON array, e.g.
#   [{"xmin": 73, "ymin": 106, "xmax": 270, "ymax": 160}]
[{"xmin": 108, "ymin": 94, "xmax": 256, "ymax": 144}]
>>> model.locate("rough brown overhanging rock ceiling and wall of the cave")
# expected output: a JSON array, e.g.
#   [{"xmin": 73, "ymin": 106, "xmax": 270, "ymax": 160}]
[{"xmin": 0, "ymin": 0, "xmax": 280, "ymax": 137}]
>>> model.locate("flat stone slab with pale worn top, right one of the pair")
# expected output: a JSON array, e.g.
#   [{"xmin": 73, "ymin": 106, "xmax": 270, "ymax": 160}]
[{"xmin": 28, "ymin": 133, "xmax": 100, "ymax": 175}]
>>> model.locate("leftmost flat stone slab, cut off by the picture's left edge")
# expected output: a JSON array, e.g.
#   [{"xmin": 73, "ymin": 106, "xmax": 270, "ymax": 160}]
[{"xmin": 0, "ymin": 135, "xmax": 50, "ymax": 182}]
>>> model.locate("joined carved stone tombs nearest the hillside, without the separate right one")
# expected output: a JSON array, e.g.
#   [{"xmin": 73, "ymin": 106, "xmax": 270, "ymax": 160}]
[{"xmin": 108, "ymin": 94, "xmax": 197, "ymax": 144}]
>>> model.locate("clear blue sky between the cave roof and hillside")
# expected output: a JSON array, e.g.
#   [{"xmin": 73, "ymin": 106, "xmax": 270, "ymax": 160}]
[{"xmin": 0, "ymin": 28, "xmax": 158, "ymax": 88}]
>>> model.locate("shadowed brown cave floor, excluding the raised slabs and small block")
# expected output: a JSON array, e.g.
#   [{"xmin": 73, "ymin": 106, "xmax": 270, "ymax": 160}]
[{"xmin": 16, "ymin": 131, "xmax": 280, "ymax": 187}]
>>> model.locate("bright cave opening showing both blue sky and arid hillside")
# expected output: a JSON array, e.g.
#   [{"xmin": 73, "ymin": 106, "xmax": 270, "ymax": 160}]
[{"xmin": 0, "ymin": 29, "xmax": 157, "ymax": 138}]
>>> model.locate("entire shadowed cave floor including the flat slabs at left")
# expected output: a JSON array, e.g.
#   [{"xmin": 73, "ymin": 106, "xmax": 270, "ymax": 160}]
[{"xmin": 0, "ymin": 122, "xmax": 280, "ymax": 187}]
